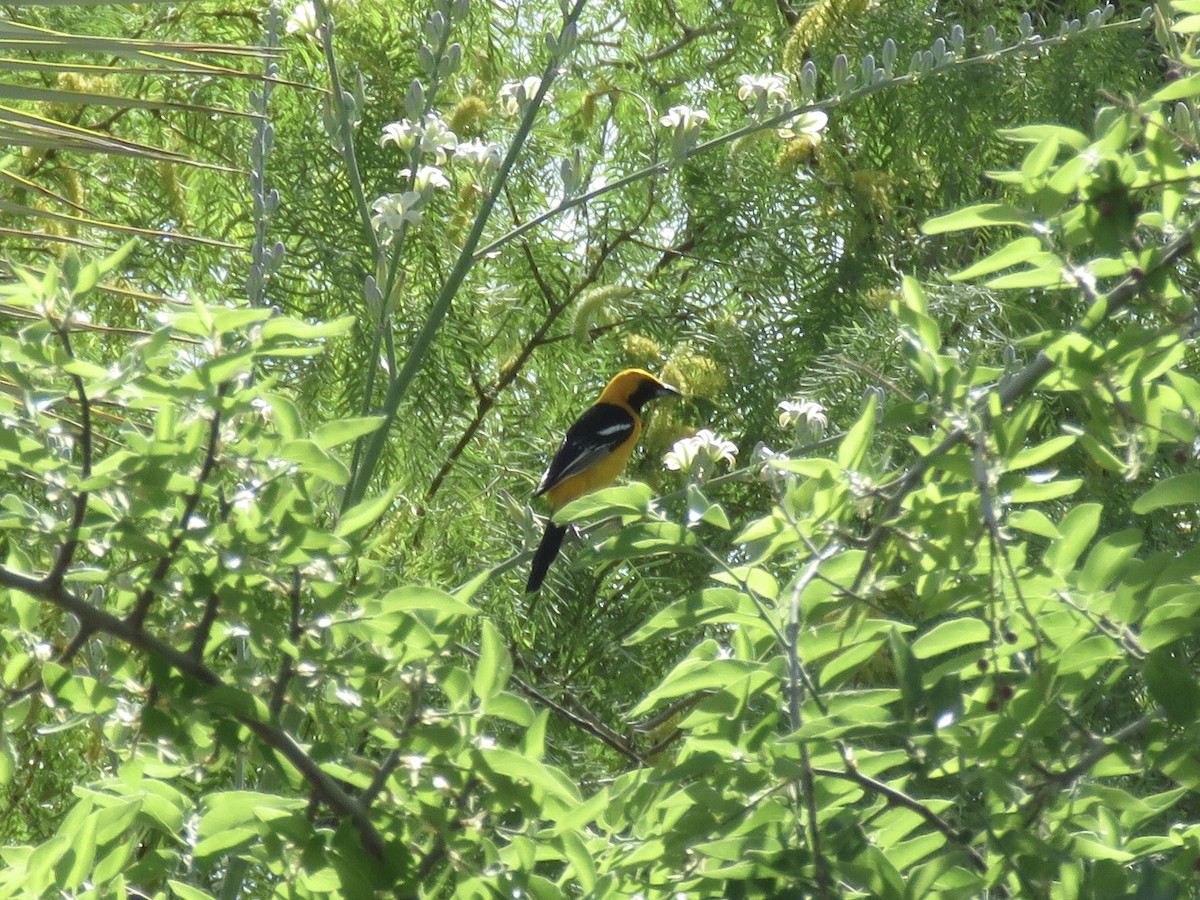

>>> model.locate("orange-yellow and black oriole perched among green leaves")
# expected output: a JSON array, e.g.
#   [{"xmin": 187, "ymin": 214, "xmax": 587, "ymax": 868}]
[{"xmin": 526, "ymin": 368, "xmax": 683, "ymax": 594}]
